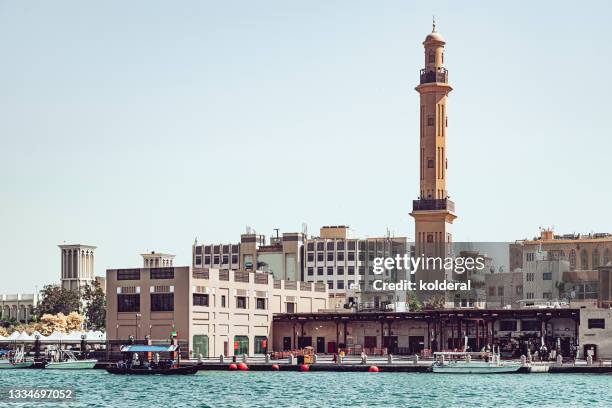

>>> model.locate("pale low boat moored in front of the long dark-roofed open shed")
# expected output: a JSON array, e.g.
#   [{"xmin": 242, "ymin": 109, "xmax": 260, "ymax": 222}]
[{"xmin": 431, "ymin": 351, "xmax": 521, "ymax": 374}]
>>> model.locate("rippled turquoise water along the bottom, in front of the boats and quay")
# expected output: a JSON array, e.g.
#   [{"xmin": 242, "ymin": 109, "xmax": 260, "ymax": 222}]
[{"xmin": 0, "ymin": 370, "xmax": 612, "ymax": 408}]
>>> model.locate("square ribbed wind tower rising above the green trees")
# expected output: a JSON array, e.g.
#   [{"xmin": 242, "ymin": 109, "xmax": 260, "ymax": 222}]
[{"xmin": 58, "ymin": 244, "xmax": 96, "ymax": 291}]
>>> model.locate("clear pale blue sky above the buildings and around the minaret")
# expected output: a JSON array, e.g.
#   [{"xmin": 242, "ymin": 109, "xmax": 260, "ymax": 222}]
[{"xmin": 0, "ymin": 0, "xmax": 612, "ymax": 293}]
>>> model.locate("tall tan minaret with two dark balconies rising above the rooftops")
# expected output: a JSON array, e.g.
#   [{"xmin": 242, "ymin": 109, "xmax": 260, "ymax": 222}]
[{"xmin": 410, "ymin": 20, "xmax": 456, "ymax": 282}]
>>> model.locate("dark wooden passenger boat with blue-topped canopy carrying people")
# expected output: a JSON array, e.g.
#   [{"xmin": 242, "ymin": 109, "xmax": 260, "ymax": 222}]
[{"xmin": 106, "ymin": 344, "xmax": 198, "ymax": 375}]
